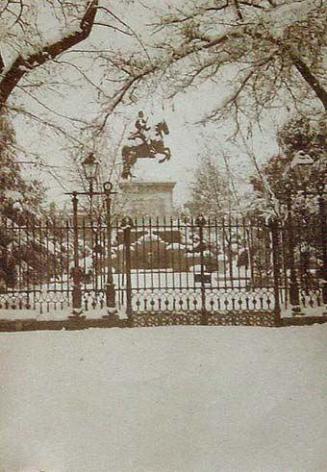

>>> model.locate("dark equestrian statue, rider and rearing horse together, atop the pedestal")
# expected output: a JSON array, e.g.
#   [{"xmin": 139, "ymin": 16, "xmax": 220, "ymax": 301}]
[{"xmin": 121, "ymin": 111, "xmax": 171, "ymax": 179}]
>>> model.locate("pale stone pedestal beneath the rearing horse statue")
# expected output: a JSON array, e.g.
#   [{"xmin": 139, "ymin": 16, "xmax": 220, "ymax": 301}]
[{"xmin": 120, "ymin": 180, "xmax": 176, "ymax": 218}]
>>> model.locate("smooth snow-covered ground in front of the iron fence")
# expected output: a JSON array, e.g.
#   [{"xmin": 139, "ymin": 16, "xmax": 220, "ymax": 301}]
[{"xmin": 0, "ymin": 325, "xmax": 327, "ymax": 472}]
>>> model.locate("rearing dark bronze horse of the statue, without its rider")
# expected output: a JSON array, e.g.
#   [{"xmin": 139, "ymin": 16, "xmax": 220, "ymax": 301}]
[{"xmin": 121, "ymin": 121, "xmax": 171, "ymax": 179}]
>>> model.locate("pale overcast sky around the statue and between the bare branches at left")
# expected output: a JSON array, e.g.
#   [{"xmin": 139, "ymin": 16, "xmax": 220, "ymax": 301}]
[{"xmin": 15, "ymin": 1, "xmax": 282, "ymax": 204}]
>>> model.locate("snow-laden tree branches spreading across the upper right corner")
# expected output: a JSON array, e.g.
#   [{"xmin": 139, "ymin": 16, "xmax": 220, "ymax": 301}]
[{"xmin": 113, "ymin": 0, "xmax": 327, "ymax": 130}]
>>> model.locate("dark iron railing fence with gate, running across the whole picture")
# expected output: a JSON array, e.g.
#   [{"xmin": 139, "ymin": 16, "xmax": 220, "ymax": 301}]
[{"xmin": 0, "ymin": 213, "xmax": 327, "ymax": 326}]
